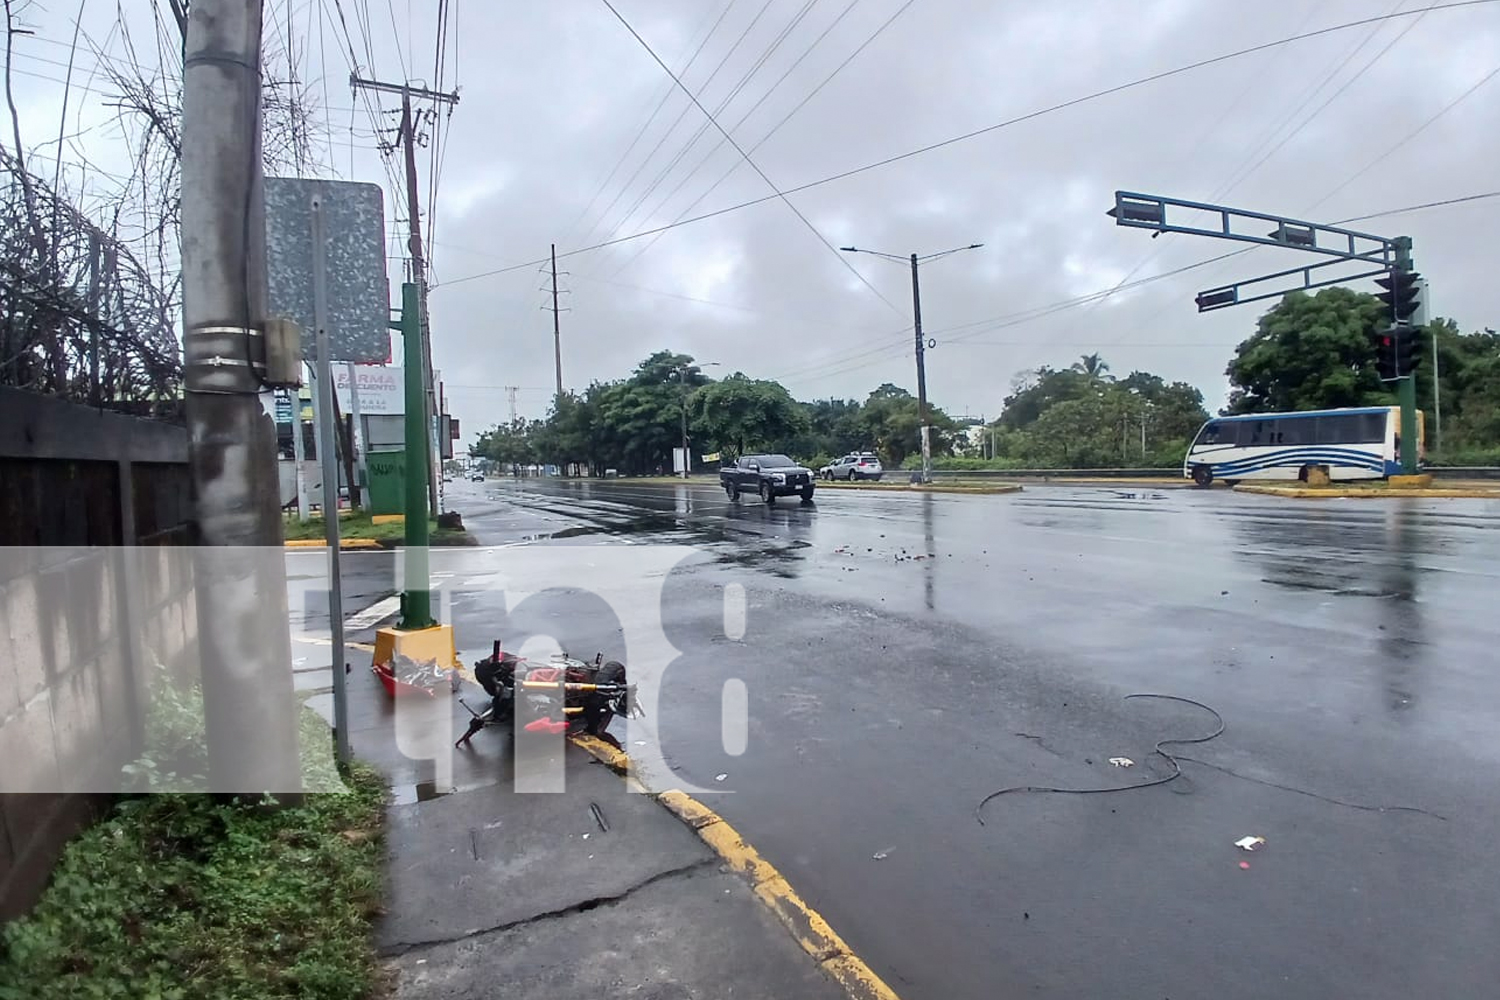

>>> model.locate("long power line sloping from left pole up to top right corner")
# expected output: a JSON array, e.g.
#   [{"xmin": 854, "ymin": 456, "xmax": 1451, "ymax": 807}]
[{"xmin": 444, "ymin": 0, "xmax": 1497, "ymax": 285}]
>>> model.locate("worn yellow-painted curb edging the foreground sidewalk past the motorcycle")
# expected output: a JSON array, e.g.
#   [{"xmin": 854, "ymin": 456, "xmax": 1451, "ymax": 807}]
[{"xmin": 573, "ymin": 736, "xmax": 900, "ymax": 1000}]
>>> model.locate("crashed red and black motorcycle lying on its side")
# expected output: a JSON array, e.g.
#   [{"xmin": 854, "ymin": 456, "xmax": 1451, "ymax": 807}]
[{"xmin": 453, "ymin": 639, "xmax": 641, "ymax": 747}]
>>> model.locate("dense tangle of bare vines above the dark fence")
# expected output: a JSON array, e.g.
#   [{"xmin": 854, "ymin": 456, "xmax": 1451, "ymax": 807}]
[{"xmin": 0, "ymin": 148, "xmax": 182, "ymax": 418}]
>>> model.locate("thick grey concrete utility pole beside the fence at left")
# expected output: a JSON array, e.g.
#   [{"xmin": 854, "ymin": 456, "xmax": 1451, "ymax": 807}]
[{"xmin": 182, "ymin": 0, "xmax": 302, "ymax": 793}]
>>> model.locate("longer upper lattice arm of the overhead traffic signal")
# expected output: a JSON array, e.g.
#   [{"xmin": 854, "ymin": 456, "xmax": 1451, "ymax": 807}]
[{"xmin": 1106, "ymin": 190, "xmax": 1395, "ymax": 267}]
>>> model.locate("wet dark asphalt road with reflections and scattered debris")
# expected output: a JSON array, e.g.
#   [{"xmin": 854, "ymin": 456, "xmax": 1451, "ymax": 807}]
[{"xmin": 319, "ymin": 481, "xmax": 1500, "ymax": 1000}]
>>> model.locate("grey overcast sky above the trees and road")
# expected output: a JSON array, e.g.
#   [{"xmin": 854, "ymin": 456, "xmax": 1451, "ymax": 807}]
[{"xmin": 2, "ymin": 0, "xmax": 1500, "ymax": 439}]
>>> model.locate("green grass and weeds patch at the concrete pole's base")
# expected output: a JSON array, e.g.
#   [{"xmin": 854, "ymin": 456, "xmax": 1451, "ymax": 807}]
[{"xmin": 0, "ymin": 743, "xmax": 386, "ymax": 1000}]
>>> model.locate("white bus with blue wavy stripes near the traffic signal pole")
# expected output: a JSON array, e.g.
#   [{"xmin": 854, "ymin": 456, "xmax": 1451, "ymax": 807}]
[{"xmin": 1182, "ymin": 406, "xmax": 1425, "ymax": 486}]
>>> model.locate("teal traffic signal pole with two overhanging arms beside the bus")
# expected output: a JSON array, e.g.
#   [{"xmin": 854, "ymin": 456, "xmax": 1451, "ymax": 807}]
[{"xmin": 1106, "ymin": 190, "xmax": 1418, "ymax": 475}]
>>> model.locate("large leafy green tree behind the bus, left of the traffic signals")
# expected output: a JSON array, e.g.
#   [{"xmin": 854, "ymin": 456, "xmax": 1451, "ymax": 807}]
[{"xmin": 1226, "ymin": 286, "xmax": 1395, "ymax": 414}]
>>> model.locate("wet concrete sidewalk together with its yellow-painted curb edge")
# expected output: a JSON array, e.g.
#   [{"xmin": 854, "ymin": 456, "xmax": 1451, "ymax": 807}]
[{"xmin": 299, "ymin": 645, "xmax": 870, "ymax": 1000}]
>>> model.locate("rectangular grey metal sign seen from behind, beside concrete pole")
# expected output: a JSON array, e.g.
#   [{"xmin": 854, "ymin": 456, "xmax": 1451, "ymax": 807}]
[{"xmin": 266, "ymin": 177, "xmax": 390, "ymax": 364}]
